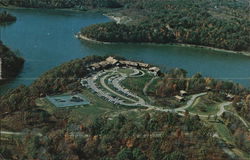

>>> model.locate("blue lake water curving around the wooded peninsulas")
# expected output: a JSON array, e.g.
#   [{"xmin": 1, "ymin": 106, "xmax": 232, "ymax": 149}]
[{"xmin": 0, "ymin": 9, "xmax": 250, "ymax": 93}]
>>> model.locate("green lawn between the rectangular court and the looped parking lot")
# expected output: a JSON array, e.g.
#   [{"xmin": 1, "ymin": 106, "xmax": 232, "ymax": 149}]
[{"xmin": 36, "ymin": 89, "xmax": 145, "ymax": 124}]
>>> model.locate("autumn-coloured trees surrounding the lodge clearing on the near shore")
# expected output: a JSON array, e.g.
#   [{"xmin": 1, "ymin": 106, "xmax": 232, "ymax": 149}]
[{"xmin": 0, "ymin": 56, "xmax": 250, "ymax": 160}]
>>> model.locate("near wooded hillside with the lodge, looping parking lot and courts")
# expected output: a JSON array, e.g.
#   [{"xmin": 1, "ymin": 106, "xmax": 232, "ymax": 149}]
[{"xmin": 0, "ymin": 56, "xmax": 249, "ymax": 160}]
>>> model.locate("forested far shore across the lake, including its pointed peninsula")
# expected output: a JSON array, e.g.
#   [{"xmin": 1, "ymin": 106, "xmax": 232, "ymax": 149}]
[{"xmin": 0, "ymin": 0, "xmax": 250, "ymax": 53}]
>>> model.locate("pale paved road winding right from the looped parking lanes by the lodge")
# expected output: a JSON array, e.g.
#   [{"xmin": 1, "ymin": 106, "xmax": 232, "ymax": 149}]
[{"xmin": 83, "ymin": 69, "xmax": 250, "ymax": 132}]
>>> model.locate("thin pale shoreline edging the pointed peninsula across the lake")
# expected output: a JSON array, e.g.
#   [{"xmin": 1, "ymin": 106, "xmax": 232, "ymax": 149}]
[{"xmin": 75, "ymin": 33, "xmax": 250, "ymax": 57}]
